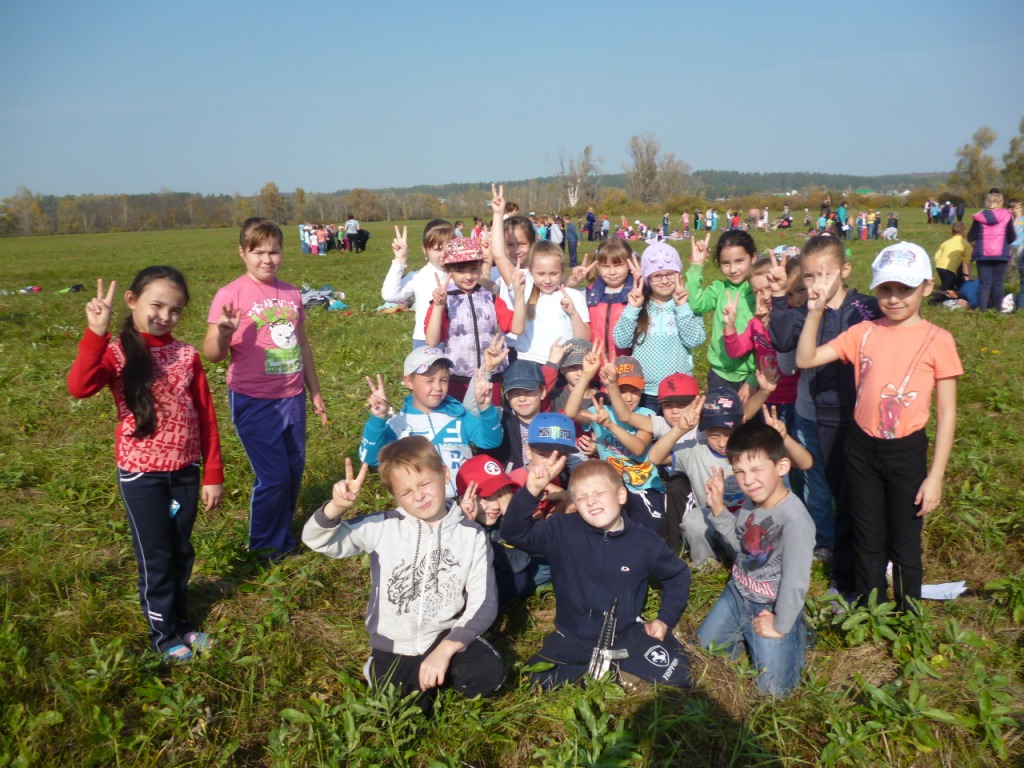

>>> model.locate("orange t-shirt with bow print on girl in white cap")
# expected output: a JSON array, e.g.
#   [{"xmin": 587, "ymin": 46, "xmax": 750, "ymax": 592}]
[{"xmin": 828, "ymin": 318, "xmax": 964, "ymax": 439}]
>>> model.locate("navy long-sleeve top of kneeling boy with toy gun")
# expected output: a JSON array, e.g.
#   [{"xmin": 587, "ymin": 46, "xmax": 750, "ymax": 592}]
[{"xmin": 502, "ymin": 487, "xmax": 690, "ymax": 642}]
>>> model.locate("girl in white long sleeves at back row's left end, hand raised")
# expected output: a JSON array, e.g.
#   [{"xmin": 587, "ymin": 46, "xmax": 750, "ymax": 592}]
[{"xmin": 381, "ymin": 219, "xmax": 455, "ymax": 349}]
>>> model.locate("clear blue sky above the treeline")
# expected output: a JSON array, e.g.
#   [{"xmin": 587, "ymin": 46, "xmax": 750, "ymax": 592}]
[{"xmin": 0, "ymin": 0, "xmax": 1024, "ymax": 198}]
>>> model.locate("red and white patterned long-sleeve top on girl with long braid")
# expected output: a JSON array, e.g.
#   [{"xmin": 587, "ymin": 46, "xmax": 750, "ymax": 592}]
[{"xmin": 68, "ymin": 329, "xmax": 224, "ymax": 485}]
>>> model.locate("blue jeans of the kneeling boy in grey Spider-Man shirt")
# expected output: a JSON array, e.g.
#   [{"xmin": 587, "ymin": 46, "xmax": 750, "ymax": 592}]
[{"xmin": 697, "ymin": 581, "xmax": 807, "ymax": 696}]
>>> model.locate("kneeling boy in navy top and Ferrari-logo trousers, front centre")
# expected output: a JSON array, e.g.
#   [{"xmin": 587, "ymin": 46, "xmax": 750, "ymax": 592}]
[{"xmin": 502, "ymin": 457, "xmax": 690, "ymax": 688}]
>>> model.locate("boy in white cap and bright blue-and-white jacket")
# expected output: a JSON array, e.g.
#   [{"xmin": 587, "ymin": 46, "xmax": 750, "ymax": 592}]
[{"xmin": 359, "ymin": 347, "xmax": 502, "ymax": 499}]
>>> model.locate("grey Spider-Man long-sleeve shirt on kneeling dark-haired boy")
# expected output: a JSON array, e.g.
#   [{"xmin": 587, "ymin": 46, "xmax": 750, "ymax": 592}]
[{"xmin": 711, "ymin": 493, "xmax": 814, "ymax": 635}]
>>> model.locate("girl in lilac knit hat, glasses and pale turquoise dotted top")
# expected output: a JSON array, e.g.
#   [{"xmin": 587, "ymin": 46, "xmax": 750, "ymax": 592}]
[{"xmin": 614, "ymin": 244, "xmax": 704, "ymax": 413}]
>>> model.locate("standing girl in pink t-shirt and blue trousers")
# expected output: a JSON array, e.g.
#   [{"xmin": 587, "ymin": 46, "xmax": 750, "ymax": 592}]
[{"xmin": 203, "ymin": 217, "xmax": 327, "ymax": 558}]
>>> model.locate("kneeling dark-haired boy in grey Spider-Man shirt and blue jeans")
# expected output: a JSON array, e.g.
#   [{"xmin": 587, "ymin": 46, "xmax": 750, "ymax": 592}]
[{"xmin": 697, "ymin": 422, "xmax": 814, "ymax": 696}]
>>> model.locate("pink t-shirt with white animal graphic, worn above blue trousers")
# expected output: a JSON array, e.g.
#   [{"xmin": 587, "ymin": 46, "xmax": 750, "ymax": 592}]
[{"xmin": 207, "ymin": 274, "xmax": 306, "ymax": 400}]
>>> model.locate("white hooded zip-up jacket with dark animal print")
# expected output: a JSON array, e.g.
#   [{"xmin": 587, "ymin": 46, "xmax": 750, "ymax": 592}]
[{"xmin": 302, "ymin": 502, "xmax": 498, "ymax": 656}]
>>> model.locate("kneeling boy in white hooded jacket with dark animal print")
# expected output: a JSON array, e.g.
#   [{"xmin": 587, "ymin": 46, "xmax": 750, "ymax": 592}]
[{"xmin": 302, "ymin": 436, "xmax": 505, "ymax": 711}]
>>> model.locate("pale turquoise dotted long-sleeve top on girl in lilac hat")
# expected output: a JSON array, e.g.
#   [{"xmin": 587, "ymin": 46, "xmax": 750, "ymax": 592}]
[{"xmin": 614, "ymin": 299, "xmax": 706, "ymax": 396}]
